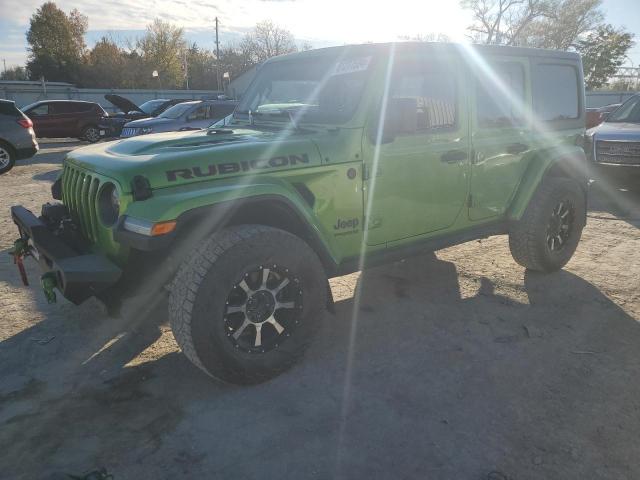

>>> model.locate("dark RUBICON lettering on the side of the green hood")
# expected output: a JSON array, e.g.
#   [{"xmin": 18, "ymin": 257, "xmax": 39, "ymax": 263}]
[{"xmin": 165, "ymin": 153, "xmax": 309, "ymax": 182}]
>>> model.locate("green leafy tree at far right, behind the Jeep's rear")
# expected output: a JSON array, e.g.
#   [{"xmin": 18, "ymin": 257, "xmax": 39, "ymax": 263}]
[{"xmin": 576, "ymin": 25, "xmax": 634, "ymax": 89}]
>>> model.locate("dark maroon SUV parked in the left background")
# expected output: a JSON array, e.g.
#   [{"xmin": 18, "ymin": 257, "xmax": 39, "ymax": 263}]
[{"xmin": 22, "ymin": 100, "xmax": 107, "ymax": 143}]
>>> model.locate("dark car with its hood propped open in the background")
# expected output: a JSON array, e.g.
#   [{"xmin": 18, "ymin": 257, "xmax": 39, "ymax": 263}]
[{"xmin": 98, "ymin": 93, "xmax": 187, "ymax": 138}]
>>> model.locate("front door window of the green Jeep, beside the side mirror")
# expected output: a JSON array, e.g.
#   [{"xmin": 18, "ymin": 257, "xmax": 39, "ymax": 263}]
[{"xmin": 390, "ymin": 62, "xmax": 457, "ymax": 132}]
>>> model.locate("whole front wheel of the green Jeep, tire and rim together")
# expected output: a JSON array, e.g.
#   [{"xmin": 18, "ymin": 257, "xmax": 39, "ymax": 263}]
[{"xmin": 169, "ymin": 225, "xmax": 327, "ymax": 384}]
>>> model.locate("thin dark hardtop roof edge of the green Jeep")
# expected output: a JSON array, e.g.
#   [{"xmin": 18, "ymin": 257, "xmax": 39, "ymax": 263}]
[{"xmin": 267, "ymin": 42, "xmax": 580, "ymax": 63}]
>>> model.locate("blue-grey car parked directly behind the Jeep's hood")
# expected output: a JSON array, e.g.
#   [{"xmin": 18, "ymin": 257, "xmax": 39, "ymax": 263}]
[{"xmin": 120, "ymin": 100, "xmax": 236, "ymax": 138}]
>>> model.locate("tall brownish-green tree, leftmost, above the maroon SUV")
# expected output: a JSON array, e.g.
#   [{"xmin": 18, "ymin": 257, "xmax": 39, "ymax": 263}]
[{"xmin": 27, "ymin": 2, "xmax": 88, "ymax": 82}]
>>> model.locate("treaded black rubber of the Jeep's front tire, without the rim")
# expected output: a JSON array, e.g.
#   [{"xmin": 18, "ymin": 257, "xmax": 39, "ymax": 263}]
[{"xmin": 169, "ymin": 225, "xmax": 327, "ymax": 384}]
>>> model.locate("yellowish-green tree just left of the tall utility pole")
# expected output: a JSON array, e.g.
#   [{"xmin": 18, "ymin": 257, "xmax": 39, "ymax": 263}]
[{"xmin": 137, "ymin": 18, "xmax": 186, "ymax": 88}]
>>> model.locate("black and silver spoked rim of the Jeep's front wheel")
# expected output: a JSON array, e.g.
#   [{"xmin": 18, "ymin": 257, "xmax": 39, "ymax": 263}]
[{"xmin": 224, "ymin": 265, "xmax": 302, "ymax": 353}]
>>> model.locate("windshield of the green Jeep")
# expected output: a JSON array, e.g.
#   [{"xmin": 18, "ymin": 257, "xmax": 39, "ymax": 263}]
[{"xmin": 236, "ymin": 56, "xmax": 372, "ymax": 124}]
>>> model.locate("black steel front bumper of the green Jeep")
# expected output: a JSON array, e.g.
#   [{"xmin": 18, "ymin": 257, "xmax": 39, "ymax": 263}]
[{"xmin": 11, "ymin": 206, "xmax": 122, "ymax": 305}]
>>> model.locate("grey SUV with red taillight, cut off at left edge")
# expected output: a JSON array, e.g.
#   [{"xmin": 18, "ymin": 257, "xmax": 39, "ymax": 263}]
[{"xmin": 0, "ymin": 100, "xmax": 38, "ymax": 174}]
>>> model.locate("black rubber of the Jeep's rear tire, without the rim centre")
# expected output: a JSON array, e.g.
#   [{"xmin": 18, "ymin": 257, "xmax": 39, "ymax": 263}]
[{"xmin": 509, "ymin": 177, "xmax": 586, "ymax": 272}]
